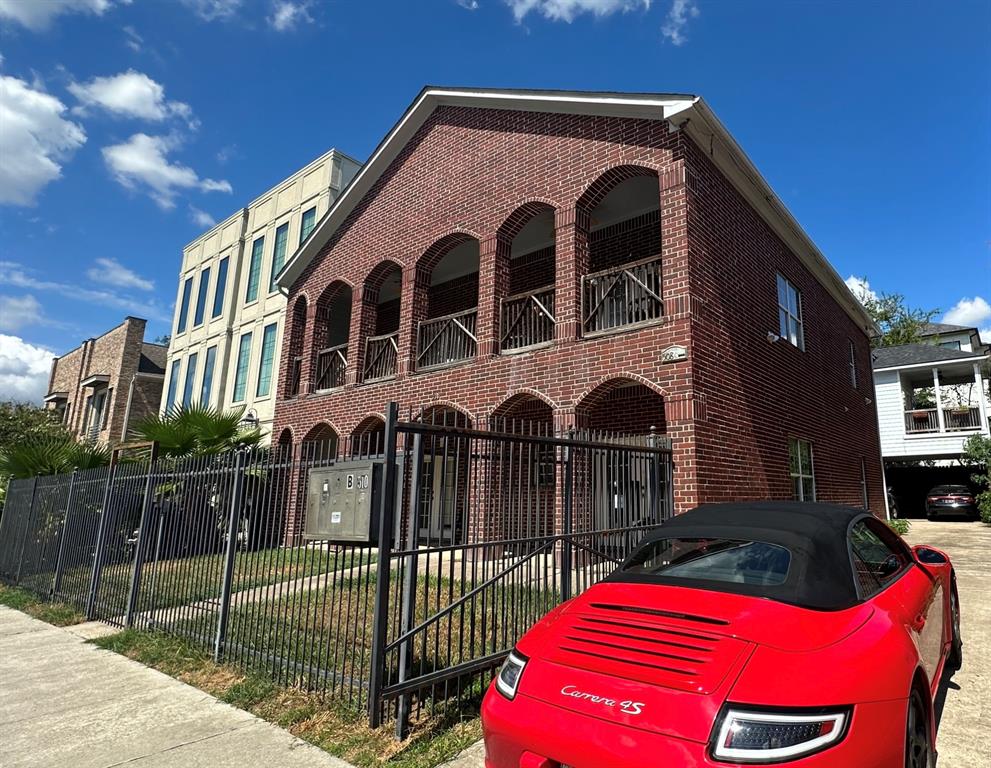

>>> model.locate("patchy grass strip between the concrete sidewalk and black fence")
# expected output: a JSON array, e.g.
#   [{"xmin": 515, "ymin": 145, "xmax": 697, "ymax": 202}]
[{"xmin": 92, "ymin": 630, "xmax": 481, "ymax": 768}]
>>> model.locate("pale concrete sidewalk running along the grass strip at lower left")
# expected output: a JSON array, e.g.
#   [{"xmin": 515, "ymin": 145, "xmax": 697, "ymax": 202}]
[{"xmin": 0, "ymin": 606, "xmax": 351, "ymax": 768}]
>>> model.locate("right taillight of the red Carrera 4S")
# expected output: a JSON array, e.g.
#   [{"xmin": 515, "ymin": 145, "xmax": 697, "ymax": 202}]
[{"xmin": 711, "ymin": 707, "xmax": 850, "ymax": 763}]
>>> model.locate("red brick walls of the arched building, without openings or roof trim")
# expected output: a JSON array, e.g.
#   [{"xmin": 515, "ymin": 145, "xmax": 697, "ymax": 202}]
[{"xmin": 275, "ymin": 107, "xmax": 880, "ymax": 528}]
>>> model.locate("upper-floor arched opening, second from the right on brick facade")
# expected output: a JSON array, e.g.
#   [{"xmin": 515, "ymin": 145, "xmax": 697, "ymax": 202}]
[{"xmin": 499, "ymin": 203, "xmax": 555, "ymax": 352}]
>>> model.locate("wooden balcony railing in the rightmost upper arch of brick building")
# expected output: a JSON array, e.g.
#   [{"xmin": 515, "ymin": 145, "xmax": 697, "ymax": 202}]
[{"xmin": 582, "ymin": 256, "xmax": 664, "ymax": 335}]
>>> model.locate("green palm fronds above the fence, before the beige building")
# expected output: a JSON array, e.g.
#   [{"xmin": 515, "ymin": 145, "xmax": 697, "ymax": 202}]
[{"xmin": 131, "ymin": 405, "xmax": 262, "ymax": 457}]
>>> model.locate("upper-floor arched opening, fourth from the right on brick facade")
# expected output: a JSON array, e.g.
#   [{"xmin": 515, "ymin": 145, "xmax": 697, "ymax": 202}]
[{"xmin": 362, "ymin": 261, "xmax": 403, "ymax": 381}]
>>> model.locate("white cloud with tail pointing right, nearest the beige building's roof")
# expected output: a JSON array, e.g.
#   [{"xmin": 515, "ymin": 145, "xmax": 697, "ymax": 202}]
[{"xmin": 103, "ymin": 133, "xmax": 233, "ymax": 210}]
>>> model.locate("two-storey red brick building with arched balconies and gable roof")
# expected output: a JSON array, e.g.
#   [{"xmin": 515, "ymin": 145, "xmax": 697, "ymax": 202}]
[{"xmin": 273, "ymin": 88, "xmax": 884, "ymax": 512}]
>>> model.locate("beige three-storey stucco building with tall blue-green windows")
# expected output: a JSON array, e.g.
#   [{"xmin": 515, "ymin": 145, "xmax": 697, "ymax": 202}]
[{"xmin": 161, "ymin": 149, "xmax": 359, "ymax": 439}]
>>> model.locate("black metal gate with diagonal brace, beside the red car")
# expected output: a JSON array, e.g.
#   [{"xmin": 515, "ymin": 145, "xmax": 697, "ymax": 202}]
[{"xmin": 369, "ymin": 409, "xmax": 672, "ymax": 738}]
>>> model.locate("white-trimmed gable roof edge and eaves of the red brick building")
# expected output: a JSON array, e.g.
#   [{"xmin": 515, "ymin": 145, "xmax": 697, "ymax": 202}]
[{"xmin": 276, "ymin": 86, "xmax": 877, "ymax": 334}]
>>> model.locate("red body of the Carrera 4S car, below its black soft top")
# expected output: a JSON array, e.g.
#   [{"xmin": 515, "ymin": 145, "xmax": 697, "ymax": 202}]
[{"xmin": 482, "ymin": 504, "xmax": 959, "ymax": 768}]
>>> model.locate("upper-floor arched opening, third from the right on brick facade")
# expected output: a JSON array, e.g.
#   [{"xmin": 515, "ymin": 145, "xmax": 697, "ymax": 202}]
[{"xmin": 416, "ymin": 234, "xmax": 479, "ymax": 370}]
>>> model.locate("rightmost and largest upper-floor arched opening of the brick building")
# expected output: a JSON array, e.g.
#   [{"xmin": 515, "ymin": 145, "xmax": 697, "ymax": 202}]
[{"xmin": 577, "ymin": 166, "xmax": 664, "ymax": 335}]
